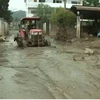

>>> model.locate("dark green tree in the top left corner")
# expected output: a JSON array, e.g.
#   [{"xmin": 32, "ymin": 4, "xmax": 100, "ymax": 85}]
[{"xmin": 0, "ymin": 0, "xmax": 12, "ymax": 22}]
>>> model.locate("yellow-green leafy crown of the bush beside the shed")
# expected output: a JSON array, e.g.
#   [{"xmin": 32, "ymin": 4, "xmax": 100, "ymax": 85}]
[{"xmin": 51, "ymin": 8, "xmax": 76, "ymax": 27}]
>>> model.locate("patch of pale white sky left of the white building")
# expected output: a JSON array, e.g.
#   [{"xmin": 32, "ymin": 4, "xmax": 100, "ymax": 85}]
[{"xmin": 9, "ymin": 0, "xmax": 26, "ymax": 11}]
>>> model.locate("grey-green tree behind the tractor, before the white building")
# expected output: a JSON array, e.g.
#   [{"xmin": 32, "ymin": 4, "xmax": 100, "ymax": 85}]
[{"xmin": 36, "ymin": 4, "xmax": 53, "ymax": 23}]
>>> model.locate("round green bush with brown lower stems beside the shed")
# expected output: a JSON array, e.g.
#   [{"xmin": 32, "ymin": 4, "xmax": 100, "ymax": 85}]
[{"xmin": 51, "ymin": 8, "xmax": 76, "ymax": 41}]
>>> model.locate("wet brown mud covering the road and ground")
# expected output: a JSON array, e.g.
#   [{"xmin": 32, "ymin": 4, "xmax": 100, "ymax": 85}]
[{"xmin": 0, "ymin": 31, "xmax": 100, "ymax": 99}]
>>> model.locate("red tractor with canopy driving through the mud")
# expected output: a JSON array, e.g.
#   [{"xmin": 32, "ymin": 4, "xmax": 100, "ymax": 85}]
[{"xmin": 14, "ymin": 17, "xmax": 51, "ymax": 47}]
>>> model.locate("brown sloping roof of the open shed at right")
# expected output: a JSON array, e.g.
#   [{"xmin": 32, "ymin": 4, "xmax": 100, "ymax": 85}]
[{"xmin": 70, "ymin": 6, "xmax": 100, "ymax": 19}]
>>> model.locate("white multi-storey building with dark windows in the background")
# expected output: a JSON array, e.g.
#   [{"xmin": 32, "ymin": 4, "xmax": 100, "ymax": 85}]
[{"xmin": 24, "ymin": 0, "xmax": 83, "ymax": 17}]
